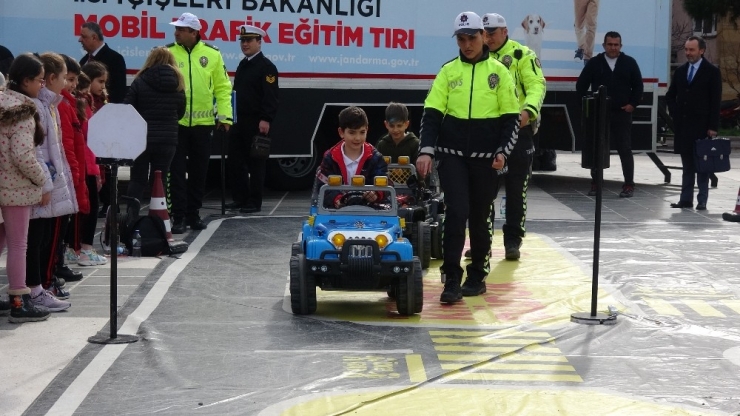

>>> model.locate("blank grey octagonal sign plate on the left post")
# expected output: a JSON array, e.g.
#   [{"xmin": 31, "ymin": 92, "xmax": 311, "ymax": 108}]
[{"xmin": 87, "ymin": 104, "xmax": 146, "ymax": 160}]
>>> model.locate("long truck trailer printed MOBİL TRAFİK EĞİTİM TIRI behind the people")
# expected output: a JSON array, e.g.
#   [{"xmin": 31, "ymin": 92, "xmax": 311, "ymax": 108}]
[{"xmin": 0, "ymin": 0, "xmax": 671, "ymax": 190}]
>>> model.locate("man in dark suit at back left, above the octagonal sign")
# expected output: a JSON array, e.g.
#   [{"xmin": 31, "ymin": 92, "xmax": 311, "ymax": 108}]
[{"xmin": 79, "ymin": 22, "xmax": 126, "ymax": 103}]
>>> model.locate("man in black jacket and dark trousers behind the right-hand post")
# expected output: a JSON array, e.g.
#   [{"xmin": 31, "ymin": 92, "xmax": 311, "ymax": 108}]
[{"xmin": 576, "ymin": 32, "xmax": 643, "ymax": 198}]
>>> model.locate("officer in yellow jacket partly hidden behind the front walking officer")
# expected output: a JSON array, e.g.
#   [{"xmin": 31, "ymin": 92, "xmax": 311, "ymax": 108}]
[{"xmin": 483, "ymin": 13, "xmax": 546, "ymax": 260}]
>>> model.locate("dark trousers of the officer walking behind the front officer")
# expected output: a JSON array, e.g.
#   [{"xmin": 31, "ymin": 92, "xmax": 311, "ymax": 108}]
[{"xmin": 500, "ymin": 125, "xmax": 534, "ymax": 246}]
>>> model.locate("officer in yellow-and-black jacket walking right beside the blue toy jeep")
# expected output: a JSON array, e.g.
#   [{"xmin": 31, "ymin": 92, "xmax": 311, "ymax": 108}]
[{"xmin": 416, "ymin": 12, "xmax": 519, "ymax": 303}]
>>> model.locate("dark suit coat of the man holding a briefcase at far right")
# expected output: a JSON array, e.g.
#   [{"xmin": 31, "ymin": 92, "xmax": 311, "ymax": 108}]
[{"xmin": 666, "ymin": 58, "xmax": 722, "ymax": 154}]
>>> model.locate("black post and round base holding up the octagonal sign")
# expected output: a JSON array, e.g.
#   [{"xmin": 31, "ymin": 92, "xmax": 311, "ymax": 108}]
[{"xmin": 87, "ymin": 161, "xmax": 139, "ymax": 344}]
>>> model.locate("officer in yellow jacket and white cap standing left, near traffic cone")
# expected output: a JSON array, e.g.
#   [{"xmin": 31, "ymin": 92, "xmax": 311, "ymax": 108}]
[{"xmin": 167, "ymin": 13, "xmax": 233, "ymax": 234}]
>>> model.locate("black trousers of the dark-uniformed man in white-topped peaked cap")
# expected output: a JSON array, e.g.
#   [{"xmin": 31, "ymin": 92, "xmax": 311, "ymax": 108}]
[{"xmin": 228, "ymin": 119, "xmax": 267, "ymax": 208}]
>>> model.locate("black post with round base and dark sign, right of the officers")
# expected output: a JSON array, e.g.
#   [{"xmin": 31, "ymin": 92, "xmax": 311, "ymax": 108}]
[{"xmin": 570, "ymin": 85, "xmax": 617, "ymax": 325}]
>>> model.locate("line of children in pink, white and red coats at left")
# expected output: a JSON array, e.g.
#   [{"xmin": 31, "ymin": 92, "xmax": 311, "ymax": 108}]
[{"xmin": 0, "ymin": 52, "xmax": 107, "ymax": 323}]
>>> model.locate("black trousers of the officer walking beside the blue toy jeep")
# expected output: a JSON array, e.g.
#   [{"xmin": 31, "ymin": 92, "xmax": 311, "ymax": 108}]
[{"xmin": 437, "ymin": 153, "xmax": 499, "ymax": 282}]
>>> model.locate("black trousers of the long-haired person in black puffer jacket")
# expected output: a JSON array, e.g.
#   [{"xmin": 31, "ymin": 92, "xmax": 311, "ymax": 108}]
[{"xmin": 126, "ymin": 144, "xmax": 177, "ymax": 202}]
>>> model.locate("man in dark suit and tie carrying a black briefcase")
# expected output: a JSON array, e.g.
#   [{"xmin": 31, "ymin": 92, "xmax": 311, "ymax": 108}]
[{"xmin": 666, "ymin": 36, "xmax": 722, "ymax": 210}]
